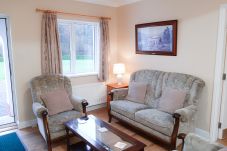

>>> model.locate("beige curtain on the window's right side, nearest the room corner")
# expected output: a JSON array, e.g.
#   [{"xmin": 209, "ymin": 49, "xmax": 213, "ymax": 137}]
[{"xmin": 98, "ymin": 18, "xmax": 110, "ymax": 81}]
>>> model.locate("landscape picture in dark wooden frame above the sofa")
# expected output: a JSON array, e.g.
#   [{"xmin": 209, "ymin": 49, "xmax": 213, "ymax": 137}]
[{"xmin": 136, "ymin": 20, "xmax": 177, "ymax": 56}]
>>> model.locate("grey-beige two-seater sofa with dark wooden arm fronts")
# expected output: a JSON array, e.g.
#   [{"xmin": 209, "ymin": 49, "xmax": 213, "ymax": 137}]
[{"xmin": 109, "ymin": 70, "xmax": 205, "ymax": 149}]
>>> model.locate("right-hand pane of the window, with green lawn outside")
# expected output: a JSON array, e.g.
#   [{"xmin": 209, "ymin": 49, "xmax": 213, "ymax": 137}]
[{"xmin": 74, "ymin": 24, "xmax": 95, "ymax": 73}]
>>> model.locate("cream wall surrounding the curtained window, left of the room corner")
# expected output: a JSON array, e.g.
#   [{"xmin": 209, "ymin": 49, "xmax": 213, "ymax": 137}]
[{"xmin": 0, "ymin": 0, "xmax": 117, "ymax": 123}]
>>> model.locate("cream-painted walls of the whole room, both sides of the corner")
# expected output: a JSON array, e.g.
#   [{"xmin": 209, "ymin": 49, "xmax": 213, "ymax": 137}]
[{"xmin": 0, "ymin": 0, "xmax": 226, "ymax": 131}]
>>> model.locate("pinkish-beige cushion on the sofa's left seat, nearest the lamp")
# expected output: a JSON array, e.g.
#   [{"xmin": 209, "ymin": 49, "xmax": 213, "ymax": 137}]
[{"xmin": 126, "ymin": 82, "xmax": 147, "ymax": 104}]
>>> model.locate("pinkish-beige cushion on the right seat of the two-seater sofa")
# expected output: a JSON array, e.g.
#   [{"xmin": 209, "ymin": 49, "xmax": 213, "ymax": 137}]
[{"xmin": 159, "ymin": 88, "xmax": 186, "ymax": 114}]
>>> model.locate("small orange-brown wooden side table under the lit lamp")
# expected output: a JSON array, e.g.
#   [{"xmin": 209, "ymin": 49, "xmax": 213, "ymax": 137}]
[{"xmin": 106, "ymin": 83, "xmax": 128, "ymax": 111}]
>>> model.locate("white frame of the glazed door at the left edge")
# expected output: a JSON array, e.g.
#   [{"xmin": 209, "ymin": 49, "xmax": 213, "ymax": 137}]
[{"xmin": 0, "ymin": 13, "xmax": 19, "ymax": 129}]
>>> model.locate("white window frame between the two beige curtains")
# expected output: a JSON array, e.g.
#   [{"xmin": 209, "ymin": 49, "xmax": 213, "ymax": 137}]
[{"xmin": 58, "ymin": 19, "xmax": 100, "ymax": 77}]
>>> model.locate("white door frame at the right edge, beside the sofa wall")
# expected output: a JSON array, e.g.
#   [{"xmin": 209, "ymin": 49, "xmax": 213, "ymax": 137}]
[{"xmin": 210, "ymin": 4, "xmax": 227, "ymax": 142}]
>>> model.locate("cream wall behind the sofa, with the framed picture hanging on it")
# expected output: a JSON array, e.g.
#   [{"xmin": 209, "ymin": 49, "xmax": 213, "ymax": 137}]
[{"xmin": 118, "ymin": 0, "xmax": 226, "ymax": 131}]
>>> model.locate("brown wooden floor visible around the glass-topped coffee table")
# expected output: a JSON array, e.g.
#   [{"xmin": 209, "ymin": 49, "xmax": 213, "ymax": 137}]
[{"xmin": 6, "ymin": 108, "xmax": 227, "ymax": 151}]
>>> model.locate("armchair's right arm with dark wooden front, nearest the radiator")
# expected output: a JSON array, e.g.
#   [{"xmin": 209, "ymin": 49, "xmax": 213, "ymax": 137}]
[{"xmin": 70, "ymin": 96, "xmax": 88, "ymax": 113}]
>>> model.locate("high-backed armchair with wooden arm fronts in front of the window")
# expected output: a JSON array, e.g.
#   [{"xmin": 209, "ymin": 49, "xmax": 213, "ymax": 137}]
[{"xmin": 30, "ymin": 75, "xmax": 87, "ymax": 151}]
